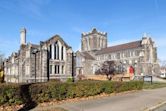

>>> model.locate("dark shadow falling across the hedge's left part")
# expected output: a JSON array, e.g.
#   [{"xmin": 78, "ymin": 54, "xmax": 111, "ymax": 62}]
[{"xmin": 18, "ymin": 84, "xmax": 37, "ymax": 111}]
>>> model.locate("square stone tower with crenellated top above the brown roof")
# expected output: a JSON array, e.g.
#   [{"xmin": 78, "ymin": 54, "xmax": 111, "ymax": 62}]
[{"xmin": 81, "ymin": 28, "xmax": 107, "ymax": 51}]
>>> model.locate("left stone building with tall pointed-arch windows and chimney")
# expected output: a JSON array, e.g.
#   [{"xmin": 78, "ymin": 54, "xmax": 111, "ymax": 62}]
[{"xmin": 4, "ymin": 29, "xmax": 72, "ymax": 83}]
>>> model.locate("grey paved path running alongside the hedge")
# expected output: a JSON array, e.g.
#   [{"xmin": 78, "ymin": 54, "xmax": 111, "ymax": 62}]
[{"xmin": 31, "ymin": 88, "xmax": 166, "ymax": 111}]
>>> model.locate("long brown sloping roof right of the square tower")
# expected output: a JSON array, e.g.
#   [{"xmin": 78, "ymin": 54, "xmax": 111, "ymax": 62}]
[{"xmin": 96, "ymin": 40, "xmax": 142, "ymax": 55}]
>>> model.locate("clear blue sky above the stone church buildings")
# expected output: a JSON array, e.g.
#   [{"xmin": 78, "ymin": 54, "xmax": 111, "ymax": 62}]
[{"xmin": 0, "ymin": 0, "xmax": 166, "ymax": 60}]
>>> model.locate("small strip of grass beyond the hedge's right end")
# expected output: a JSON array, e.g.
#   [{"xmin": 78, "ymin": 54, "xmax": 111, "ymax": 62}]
[{"xmin": 143, "ymin": 82, "xmax": 166, "ymax": 89}]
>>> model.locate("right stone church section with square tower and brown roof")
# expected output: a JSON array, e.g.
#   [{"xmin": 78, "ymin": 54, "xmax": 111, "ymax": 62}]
[{"xmin": 76, "ymin": 28, "xmax": 159, "ymax": 76}]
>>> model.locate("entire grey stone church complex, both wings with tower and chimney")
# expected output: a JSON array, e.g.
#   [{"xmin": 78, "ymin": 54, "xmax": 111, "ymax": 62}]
[{"xmin": 4, "ymin": 28, "xmax": 159, "ymax": 83}]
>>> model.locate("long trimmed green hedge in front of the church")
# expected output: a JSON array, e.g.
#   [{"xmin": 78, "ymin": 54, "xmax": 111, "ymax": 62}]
[{"xmin": 0, "ymin": 80, "xmax": 143, "ymax": 105}]
